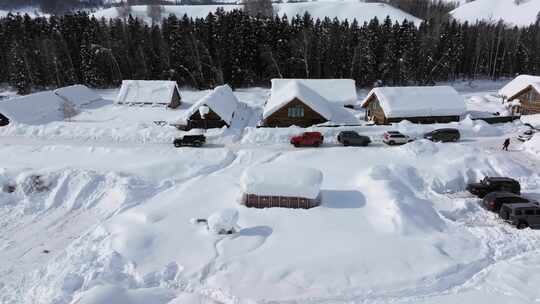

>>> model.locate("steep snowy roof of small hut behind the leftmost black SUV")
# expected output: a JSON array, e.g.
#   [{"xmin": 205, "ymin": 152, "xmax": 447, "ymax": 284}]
[{"xmin": 187, "ymin": 85, "xmax": 239, "ymax": 125}]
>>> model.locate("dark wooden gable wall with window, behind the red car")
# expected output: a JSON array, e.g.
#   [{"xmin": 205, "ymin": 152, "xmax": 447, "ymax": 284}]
[{"xmin": 263, "ymin": 98, "xmax": 328, "ymax": 128}]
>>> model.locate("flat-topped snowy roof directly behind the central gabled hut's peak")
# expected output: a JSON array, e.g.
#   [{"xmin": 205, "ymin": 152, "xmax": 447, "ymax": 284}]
[{"xmin": 271, "ymin": 78, "xmax": 358, "ymax": 105}]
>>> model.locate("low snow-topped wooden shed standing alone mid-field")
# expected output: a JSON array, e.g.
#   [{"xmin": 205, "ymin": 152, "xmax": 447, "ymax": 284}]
[{"xmin": 240, "ymin": 164, "xmax": 323, "ymax": 209}]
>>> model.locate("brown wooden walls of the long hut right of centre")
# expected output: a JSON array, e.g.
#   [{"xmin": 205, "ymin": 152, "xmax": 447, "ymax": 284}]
[{"xmin": 365, "ymin": 94, "xmax": 460, "ymax": 124}]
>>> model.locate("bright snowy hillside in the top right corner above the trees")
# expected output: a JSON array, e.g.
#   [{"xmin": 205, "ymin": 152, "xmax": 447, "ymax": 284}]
[{"xmin": 451, "ymin": 0, "xmax": 540, "ymax": 26}]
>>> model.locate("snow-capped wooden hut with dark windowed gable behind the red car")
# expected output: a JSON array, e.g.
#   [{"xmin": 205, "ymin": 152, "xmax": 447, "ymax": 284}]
[{"xmin": 262, "ymin": 80, "xmax": 333, "ymax": 127}]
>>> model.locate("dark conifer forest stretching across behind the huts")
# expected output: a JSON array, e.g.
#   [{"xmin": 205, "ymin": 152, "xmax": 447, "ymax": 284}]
[{"xmin": 4, "ymin": 10, "xmax": 540, "ymax": 93}]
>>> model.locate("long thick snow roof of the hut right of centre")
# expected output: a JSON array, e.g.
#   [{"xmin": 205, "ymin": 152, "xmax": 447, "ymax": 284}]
[{"xmin": 362, "ymin": 86, "xmax": 467, "ymax": 118}]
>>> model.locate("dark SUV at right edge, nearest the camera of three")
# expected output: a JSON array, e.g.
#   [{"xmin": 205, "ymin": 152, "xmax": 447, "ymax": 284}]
[{"xmin": 499, "ymin": 202, "xmax": 540, "ymax": 229}]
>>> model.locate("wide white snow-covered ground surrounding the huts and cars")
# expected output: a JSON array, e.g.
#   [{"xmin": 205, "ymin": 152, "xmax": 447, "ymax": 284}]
[{"xmin": 0, "ymin": 82, "xmax": 540, "ymax": 304}]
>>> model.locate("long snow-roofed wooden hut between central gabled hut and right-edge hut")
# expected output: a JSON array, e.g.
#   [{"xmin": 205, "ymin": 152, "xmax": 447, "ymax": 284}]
[{"xmin": 361, "ymin": 86, "xmax": 467, "ymax": 124}]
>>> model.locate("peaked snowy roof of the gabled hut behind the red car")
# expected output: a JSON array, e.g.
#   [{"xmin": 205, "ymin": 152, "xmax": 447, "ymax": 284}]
[{"xmin": 263, "ymin": 81, "xmax": 332, "ymax": 120}]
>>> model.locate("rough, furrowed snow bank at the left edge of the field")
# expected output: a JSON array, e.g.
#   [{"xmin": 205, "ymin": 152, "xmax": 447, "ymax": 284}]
[{"xmin": 0, "ymin": 169, "xmax": 165, "ymax": 216}]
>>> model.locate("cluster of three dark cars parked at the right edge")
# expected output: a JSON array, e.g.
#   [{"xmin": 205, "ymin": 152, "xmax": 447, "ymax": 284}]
[{"xmin": 467, "ymin": 177, "xmax": 540, "ymax": 229}]
